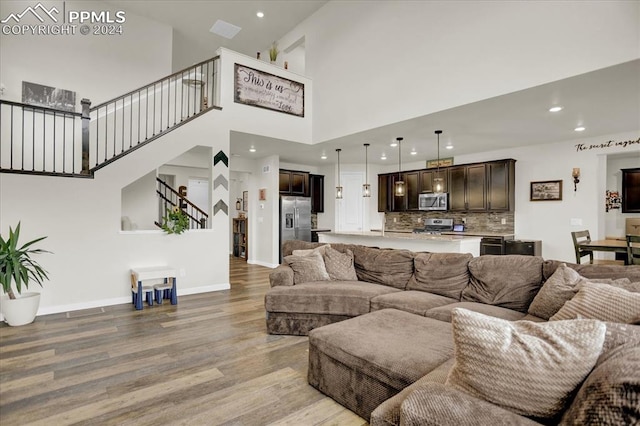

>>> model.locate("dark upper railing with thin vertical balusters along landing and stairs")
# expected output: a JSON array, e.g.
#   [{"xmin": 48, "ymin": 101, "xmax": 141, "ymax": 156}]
[{"xmin": 0, "ymin": 56, "xmax": 221, "ymax": 178}]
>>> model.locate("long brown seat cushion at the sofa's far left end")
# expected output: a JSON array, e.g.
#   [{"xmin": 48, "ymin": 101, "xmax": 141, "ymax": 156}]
[{"xmin": 264, "ymin": 281, "xmax": 399, "ymax": 316}]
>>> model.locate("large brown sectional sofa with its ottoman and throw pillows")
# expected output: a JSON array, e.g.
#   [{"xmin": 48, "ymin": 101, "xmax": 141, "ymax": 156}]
[{"xmin": 265, "ymin": 241, "xmax": 640, "ymax": 425}]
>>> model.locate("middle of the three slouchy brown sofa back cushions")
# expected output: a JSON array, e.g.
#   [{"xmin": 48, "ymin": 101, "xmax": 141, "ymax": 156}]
[{"xmin": 407, "ymin": 253, "xmax": 473, "ymax": 300}]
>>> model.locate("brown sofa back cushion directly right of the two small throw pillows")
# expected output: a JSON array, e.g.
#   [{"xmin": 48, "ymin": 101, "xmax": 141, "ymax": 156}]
[{"xmin": 351, "ymin": 246, "xmax": 415, "ymax": 290}]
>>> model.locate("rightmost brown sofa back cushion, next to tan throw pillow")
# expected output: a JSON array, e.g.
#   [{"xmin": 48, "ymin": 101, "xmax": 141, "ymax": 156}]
[{"xmin": 462, "ymin": 255, "xmax": 543, "ymax": 313}]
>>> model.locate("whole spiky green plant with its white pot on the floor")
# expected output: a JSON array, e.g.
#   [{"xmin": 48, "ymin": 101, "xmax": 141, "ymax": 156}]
[{"xmin": 0, "ymin": 222, "xmax": 49, "ymax": 326}]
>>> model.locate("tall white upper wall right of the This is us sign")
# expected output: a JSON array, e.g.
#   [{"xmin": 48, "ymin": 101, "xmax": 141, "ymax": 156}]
[{"xmin": 280, "ymin": 0, "xmax": 640, "ymax": 142}]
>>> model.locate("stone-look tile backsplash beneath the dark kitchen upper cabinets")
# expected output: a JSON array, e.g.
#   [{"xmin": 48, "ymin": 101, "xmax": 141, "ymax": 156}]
[{"xmin": 384, "ymin": 212, "xmax": 515, "ymax": 233}]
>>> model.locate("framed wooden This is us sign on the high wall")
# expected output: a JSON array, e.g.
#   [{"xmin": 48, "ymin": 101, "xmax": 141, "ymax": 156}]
[{"xmin": 234, "ymin": 64, "xmax": 304, "ymax": 117}]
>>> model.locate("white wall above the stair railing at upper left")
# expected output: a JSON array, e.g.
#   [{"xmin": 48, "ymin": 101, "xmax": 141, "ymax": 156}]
[{"xmin": 0, "ymin": 1, "xmax": 174, "ymax": 106}]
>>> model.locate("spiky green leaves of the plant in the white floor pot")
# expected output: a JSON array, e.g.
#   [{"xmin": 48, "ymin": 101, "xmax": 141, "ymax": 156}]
[{"xmin": 0, "ymin": 222, "xmax": 50, "ymax": 299}]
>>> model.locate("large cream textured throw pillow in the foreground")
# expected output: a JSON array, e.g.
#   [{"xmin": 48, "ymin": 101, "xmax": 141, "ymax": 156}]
[{"xmin": 446, "ymin": 308, "xmax": 606, "ymax": 419}]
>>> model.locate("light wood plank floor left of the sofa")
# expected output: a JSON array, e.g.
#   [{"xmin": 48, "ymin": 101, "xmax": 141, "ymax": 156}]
[{"xmin": 0, "ymin": 258, "xmax": 366, "ymax": 426}]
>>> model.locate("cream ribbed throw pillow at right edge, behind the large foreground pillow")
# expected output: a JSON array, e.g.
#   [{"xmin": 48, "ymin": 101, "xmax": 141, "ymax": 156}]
[{"xmin": 549, "ymin": 282, "xmax": 640, "ymax": 323}]
